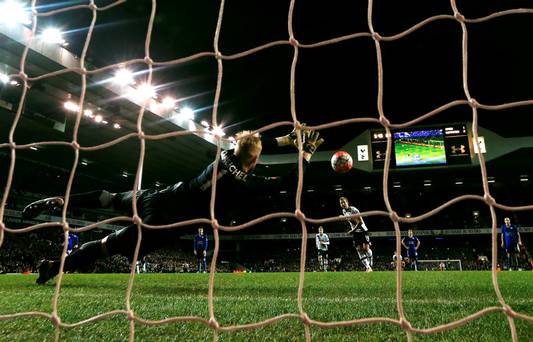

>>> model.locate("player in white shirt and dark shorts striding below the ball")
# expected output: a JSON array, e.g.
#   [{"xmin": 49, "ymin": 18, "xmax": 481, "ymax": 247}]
[{"xmin": 339, "ymin": 197, "xmax": 373, "ymax": 272}]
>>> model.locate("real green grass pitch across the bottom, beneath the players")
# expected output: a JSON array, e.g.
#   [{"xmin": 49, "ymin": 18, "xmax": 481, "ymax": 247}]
[{"xmin": 0, "ymin": 271, "xmax": 533, "ymax": 341}]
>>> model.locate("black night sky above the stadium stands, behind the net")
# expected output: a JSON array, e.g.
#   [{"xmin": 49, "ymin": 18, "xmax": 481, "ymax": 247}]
[{"xmin": 32, "ymin": 0, "xmax": 533, "ymax": 149}]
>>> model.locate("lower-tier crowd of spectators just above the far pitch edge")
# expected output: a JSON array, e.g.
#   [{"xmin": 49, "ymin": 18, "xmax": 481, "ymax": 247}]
[{"xmin": 0, "ymin": 229, "xmax": 531, "ymax": 273}]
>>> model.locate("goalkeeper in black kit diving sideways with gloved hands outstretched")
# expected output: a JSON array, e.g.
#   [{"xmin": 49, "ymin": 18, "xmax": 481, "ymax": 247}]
[{"xmin": 22, "ymin": 128, "xmax": 324, "ymax": 284}]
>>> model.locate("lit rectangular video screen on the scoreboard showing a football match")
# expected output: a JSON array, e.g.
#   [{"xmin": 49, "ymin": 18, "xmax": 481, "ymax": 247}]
[{"xmin": 393, "ymin": 129, "xmax": 446, "ymax": 166}]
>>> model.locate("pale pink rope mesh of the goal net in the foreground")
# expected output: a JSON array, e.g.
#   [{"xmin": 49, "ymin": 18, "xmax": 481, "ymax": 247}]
[{"xmin": 0, "ymin": 0, "xmax": 533, "ymax": 341}]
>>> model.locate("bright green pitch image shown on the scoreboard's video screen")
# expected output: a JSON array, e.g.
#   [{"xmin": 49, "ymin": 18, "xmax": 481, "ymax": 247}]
[{"xmin": 394, "ymin": 143, "xmax": 446, "ymax": 166}]
